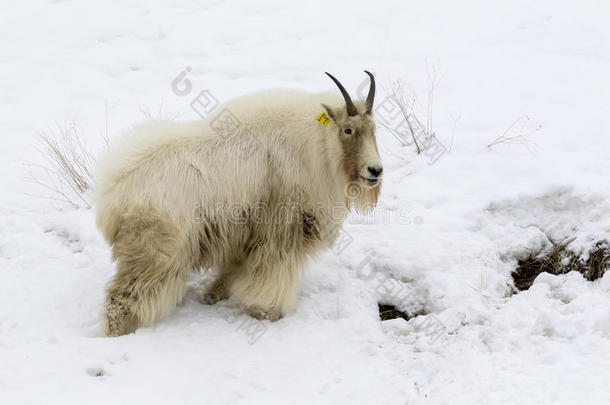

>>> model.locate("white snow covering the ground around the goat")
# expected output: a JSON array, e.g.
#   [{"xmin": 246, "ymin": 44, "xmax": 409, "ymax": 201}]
[{"xmin": 0, "ymin": 0, "xmax": 610, "ymax": 404}]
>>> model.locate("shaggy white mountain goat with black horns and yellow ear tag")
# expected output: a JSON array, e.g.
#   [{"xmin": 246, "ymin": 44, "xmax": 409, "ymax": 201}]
[{"xmin": 94, "ymin": 71, "xmax": 382, "ymax": 336}]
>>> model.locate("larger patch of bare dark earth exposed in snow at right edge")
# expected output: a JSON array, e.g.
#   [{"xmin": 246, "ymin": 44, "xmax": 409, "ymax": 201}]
[{"xmin": 511, "ymin": 239, "xmax": 610, "ymax": 290}]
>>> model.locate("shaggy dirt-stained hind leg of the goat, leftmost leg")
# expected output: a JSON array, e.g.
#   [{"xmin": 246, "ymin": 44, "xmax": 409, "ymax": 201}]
[{"xmin": 102, "ymin": 216, "xmax": 192, "ymax": 336}]
